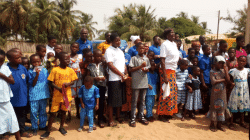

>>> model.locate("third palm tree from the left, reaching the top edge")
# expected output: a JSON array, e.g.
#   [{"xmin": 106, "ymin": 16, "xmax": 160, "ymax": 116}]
[{"xmin": 57, "ymin": 0, "xmax": 82, "ymax": 40}]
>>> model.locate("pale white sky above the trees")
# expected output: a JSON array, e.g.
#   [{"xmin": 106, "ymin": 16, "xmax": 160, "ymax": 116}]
[{"xmin": 73, "ymin": 0, "xmax": 248, "ymax": 38}]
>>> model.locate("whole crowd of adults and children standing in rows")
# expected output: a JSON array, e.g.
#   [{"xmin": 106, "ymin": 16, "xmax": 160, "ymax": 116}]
[{"xmin": 0, "ymin": 28, "xmax": 250, "ymax": 140}]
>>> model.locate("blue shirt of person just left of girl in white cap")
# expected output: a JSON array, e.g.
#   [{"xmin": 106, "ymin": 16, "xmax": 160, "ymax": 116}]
[{"xmin": 199, "ymin": 55, "xmax": 212, "ymax": 84}]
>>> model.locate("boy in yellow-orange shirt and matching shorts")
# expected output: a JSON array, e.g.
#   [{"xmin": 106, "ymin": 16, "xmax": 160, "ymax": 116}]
[{"xmin": 41, "ymin": 52, "xmax": 77, "ymax": 139}]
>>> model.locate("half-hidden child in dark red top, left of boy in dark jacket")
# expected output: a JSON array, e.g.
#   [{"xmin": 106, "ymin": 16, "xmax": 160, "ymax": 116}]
[{"xmin": 80, "ymin": 48, "xmax": 93, "ymax": 81}]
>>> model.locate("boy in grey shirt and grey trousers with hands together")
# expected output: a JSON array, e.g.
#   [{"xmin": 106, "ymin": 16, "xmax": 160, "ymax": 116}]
[{"xmin": 129, "ymin": 43, "xmax": 150, "ymax": 127}]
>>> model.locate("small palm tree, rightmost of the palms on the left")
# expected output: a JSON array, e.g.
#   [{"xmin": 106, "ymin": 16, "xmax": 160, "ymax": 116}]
[{"xmin": 80, "ymin": 13, "xmax": 98, "ymax": 40}]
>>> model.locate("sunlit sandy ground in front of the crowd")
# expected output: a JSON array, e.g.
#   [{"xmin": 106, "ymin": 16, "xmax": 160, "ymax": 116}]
[{"xmin": 7, "ymin": 101, "xmax": 248, "ymax": 140}]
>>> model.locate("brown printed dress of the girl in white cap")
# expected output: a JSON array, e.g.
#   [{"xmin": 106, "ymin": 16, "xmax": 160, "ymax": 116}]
[{"xmin": 210, "ymin": 70, "xmax": 227, "ymax": 121}]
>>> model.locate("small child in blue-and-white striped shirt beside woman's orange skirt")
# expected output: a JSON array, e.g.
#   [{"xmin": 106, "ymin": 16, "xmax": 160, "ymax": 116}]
[{"xmin": 176, "ymin": 59, "xmax": 188, "ymax": 110}]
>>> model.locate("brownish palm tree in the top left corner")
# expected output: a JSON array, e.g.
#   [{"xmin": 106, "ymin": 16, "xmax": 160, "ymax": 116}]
[{"xmin": 0, "ymin": 0, "xmax": 30, "ymax": 39}]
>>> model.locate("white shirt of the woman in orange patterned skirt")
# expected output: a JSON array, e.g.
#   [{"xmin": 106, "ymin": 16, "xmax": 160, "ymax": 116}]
[{"xmin": 160, "ymin": 40, "xmax": 179, "ymax": 70}]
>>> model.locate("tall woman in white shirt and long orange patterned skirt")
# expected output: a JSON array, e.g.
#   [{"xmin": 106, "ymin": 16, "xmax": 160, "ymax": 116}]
[{"xmin": 156, "ymin": 29, "xmax": 179, "ymax": 122}]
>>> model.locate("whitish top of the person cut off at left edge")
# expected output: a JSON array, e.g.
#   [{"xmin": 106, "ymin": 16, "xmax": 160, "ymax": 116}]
[{"xmin": 0, "ymin": 64, "xmax": 13, "ymax": 103}]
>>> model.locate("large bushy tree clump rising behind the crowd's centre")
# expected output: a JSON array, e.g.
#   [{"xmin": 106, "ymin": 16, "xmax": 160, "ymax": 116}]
[{"xmin": 109, "ymin": 4, "xmax": 158, "ymax": 41}]
